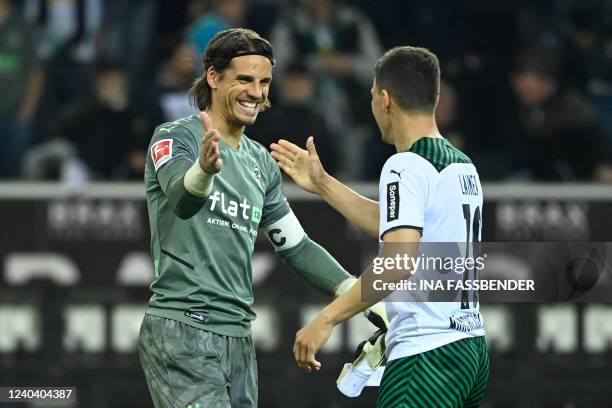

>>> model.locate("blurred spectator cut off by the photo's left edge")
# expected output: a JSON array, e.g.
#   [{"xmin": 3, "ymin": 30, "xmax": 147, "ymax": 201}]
[{"xmin": 0, "ymin": 0, "xmax": 43, "ymax": 178}]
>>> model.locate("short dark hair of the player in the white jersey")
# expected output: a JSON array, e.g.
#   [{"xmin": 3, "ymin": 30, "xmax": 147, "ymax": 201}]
[{"xmin": 374, "ymin": 46, "xmax": 440, "ymax": 113}]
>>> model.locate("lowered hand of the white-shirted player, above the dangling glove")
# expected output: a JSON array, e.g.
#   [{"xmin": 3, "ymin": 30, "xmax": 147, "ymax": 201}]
[{"xmin": 293, "ymin": 314, "xmax": 334, "ymax": 372}]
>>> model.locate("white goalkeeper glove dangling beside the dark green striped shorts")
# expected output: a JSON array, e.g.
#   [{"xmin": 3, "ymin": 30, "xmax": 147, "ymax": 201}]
[{"xmin": 336, "ymin": 330, "xmax": 386, "ymax": 397}]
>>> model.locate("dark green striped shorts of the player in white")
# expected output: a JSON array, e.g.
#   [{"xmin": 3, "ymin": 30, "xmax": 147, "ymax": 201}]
[{"xmin": 376, "ymin": 336, "xmax": 489, "ymax": 408}]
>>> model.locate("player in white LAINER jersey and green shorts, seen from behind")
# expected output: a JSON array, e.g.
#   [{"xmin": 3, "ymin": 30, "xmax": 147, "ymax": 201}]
[{"xmin": 271, "ymin": 47, "xmax": 489, "ymax": 408}]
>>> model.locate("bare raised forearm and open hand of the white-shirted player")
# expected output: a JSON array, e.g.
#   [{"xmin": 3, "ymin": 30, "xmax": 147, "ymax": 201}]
[{"xmin": 270, "ymin": 136, "xmax": 379, "ymax": 237}]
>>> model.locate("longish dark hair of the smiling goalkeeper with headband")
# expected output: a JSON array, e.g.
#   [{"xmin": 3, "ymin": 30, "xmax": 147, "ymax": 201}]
[{"xmin": 189, "ymin": 28, "xmax": 274, "ymax": 110}]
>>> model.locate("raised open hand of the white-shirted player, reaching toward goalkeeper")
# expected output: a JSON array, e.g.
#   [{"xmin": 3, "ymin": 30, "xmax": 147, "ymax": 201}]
[{"xmin": 270, "ymin": 136, "xmax": 327, "ymax": 194}]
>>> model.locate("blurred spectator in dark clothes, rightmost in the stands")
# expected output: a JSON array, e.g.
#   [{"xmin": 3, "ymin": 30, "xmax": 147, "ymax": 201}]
[{"xmin": 512, "ymin": 49, "xmax": 609, "ymax": 180}]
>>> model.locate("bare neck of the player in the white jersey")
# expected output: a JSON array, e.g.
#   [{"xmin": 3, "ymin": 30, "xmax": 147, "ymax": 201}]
[{"xmin": 391, "ymin": 114, "xmax": 442, "ymax": 152}]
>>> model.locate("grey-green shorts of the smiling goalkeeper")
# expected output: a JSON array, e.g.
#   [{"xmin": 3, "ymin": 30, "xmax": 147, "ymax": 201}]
[{"xmin": 139, "ymin": 314, "xmax": 257, "ymax": 408}]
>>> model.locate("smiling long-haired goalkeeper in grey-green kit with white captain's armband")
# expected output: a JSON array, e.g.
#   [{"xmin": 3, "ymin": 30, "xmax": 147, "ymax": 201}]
[{"xmin": 139, "ymin": 29, "xmax": 370, "ymax": 408}]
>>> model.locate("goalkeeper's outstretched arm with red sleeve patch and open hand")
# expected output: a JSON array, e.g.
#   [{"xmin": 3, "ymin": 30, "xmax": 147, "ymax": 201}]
[{"xmin": 150, "ymin": 112, "xmax": 222, "ymax": 219}]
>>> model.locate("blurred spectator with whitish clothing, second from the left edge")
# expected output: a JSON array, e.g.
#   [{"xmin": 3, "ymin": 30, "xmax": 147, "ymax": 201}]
[{"xmin": 25, "ymin": 0, "xmax": 104, "ymax": 142}]
